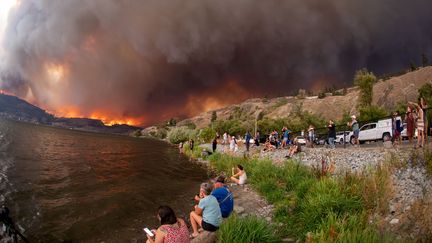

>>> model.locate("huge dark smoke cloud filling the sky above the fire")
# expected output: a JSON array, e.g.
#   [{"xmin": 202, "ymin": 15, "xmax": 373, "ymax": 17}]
[{"xmin": 1, "ymin": 0, "xmax": 432, "ymax": 123}]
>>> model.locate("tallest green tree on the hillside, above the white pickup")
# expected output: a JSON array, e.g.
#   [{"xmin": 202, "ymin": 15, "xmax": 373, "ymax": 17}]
[{"xmin": 354, "ymin": 68, "xmax": 377, "ymax": 107}]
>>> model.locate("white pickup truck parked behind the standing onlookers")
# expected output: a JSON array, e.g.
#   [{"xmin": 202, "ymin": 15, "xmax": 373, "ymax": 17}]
[{"xmin": 349, "ymin": 119, "xmax": 393, "ymax": 143}]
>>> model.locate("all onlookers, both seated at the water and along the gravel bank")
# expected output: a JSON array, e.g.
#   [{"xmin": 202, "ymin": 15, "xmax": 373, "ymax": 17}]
[{"xmin": 155, "ymin": 98, "xmax": 429, "ymax": 243}]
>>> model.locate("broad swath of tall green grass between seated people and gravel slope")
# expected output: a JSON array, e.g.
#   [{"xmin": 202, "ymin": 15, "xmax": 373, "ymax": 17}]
[{"xmin": 208, "ymin": 153, "xmax": 391, "ymax": 242}]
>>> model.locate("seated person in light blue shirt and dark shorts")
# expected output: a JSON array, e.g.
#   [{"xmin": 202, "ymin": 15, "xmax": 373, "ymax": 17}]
[{"xmin": 190, "ymin": 183, "xmax": 222, "ymax": 238}]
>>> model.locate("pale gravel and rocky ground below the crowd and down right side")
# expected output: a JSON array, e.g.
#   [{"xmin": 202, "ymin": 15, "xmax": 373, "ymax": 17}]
[{"xmin": 194, "ymin": 141, "xmax": 432, "ymax": 239}]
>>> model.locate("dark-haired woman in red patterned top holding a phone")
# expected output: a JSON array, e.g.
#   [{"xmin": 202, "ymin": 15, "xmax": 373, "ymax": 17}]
[{"xmin": 144, "ymin": 206, "xmax": 190, "ymax": 243}]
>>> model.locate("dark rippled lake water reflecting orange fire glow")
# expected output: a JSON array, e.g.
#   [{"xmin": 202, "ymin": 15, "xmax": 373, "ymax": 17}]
[{"xmin": 0, "ymin": 119, "xmax": 207, "ymax": 242}]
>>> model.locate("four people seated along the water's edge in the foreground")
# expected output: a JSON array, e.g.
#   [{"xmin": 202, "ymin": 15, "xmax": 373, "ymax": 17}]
[{"xmin": 147, "ymin": 168, "xmax": 247, "ymax": 243}]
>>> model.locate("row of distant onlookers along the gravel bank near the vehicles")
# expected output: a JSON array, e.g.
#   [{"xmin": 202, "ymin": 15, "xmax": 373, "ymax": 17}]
[{"xmin": 208, "ymin": 98, "xmax": 430, "ymax": 157}]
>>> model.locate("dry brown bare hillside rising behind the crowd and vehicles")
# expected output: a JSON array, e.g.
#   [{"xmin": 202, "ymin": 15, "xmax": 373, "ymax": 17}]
[{"xmin": 177, "ymin": 66, "xmax": 432, "ymax": 128}]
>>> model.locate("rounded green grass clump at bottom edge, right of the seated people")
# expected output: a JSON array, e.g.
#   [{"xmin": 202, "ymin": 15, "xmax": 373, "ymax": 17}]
[{"xmin": 217, "ymin": 214, "xmax": 281, "ymax": 243}]
